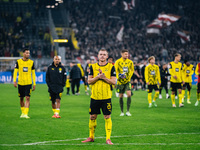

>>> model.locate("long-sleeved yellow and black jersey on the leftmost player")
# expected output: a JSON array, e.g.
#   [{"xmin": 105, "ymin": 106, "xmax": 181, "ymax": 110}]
[{"xmin": 13, "ymin": 59, "xmax": 36, "ymax": 85}]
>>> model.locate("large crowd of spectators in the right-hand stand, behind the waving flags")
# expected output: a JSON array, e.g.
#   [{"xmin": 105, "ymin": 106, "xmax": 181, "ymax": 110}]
[{"xmin": 66, "ymin": 0, "xmax": 200, "ymax": 61}]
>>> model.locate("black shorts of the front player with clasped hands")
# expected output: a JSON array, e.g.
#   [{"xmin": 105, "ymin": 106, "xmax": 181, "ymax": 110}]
[{"xmin": 89, "ymin": 98, "xmax": 112, "ymax": 115}]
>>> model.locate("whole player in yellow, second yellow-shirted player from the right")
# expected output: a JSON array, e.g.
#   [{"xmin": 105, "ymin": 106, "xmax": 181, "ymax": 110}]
[{"xmin": 169, "ymin": 53, "xmax": 185, "ymax": 107}]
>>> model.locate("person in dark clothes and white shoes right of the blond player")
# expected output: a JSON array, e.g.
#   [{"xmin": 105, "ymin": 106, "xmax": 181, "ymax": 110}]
[{"xmin": 159, "ymin": 64, "xmax": 170, "ymax": 99}]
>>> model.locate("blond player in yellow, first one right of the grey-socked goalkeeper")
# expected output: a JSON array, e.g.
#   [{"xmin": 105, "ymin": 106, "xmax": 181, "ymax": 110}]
[{"xmin": 145, "ymin": 56, "xmax": 161, "ymax": 108}]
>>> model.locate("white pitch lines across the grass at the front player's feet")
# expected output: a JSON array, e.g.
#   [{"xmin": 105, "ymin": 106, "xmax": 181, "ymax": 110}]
[{"xmin": 0, "ymin": 133, "xmax": 200, "ymax": 146}]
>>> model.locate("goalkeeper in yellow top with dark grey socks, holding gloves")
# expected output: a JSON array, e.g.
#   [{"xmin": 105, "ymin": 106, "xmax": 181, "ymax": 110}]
[{"xmin": 115, "ymin": 49, "xmax": 134, "ymax": 116}]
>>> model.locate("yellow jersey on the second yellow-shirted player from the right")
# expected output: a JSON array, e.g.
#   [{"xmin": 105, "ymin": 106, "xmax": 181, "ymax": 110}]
[{"xmin": 169, "ymin": 61, "xmax": 183, "ymax": 83}]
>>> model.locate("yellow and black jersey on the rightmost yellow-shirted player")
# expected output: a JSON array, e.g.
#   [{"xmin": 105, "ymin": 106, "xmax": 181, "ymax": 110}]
[{"xmin": 183, "ymin": 64, "xmax": 194, "ymax": 83}]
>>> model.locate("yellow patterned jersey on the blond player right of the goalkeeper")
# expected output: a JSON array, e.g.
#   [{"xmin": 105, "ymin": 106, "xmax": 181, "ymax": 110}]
[{"xmin": 145, "ymin": 64, "xmax": 161, "ymax": 85}]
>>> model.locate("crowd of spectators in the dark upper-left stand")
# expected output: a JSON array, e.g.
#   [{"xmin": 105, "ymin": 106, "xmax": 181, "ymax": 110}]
[{"xmin": 0, "ymin": 3, "xmax": 51, "ymax": 58}]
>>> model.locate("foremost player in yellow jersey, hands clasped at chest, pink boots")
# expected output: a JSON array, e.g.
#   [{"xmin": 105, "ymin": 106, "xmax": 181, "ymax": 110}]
[{"xmin": 82, "ymin": 49, "xmax": 116, "ymax": 145}]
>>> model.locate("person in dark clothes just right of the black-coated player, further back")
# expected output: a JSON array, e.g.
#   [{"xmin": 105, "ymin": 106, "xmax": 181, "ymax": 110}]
[{"xmin": 70, "ymin": 62, "xmax": 81, "ymax": 95}]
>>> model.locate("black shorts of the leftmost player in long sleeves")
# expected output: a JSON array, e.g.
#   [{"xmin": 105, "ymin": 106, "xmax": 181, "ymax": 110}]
[{"xmin": 18, "ymin": 84, "xmax": 32, "ymax": 97}]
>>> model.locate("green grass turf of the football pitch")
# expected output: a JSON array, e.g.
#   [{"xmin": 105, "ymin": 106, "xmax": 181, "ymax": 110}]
[{"xmin": 0, "ymin": 84, "xmax": 200, "ymax": 150}]
